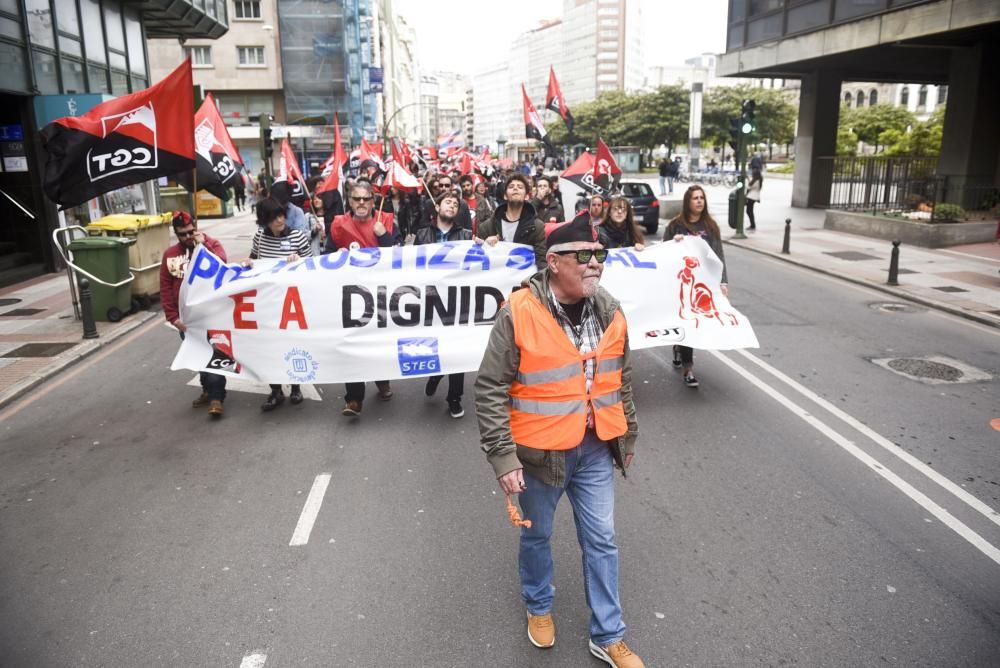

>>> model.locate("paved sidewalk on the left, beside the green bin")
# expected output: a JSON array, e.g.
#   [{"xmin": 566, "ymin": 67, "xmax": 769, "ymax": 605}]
[{"xmin": 0, "ymin": 213, "xmax": 254, "ymax": 409}]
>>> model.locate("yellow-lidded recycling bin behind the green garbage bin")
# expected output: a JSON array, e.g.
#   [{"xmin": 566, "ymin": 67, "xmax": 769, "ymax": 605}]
[{"xmin": 87, "ymin": 213, "xmax": 171, "ymax": 308}]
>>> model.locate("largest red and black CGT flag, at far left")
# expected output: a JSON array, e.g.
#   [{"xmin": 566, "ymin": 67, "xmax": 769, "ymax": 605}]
[{"xmin": 42, "ymin": 59, "xmax": 195, "ymax": 208}]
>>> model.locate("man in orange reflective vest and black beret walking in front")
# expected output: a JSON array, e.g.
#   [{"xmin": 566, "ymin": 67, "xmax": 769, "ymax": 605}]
[{"xmin": 475, "ymin": 215, "xmax": 643, "ymax": 668}]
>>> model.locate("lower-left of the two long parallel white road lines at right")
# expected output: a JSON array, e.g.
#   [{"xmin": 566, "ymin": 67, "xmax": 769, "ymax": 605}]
[{"xmin": 707, "ymin": 350, "xmax": 1000, "ymax": 565}]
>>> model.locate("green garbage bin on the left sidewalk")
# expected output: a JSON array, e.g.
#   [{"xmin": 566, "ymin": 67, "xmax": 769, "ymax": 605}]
[{"xmin": 69, "ymin": 237, "xmax": 135, "ymax": 322}]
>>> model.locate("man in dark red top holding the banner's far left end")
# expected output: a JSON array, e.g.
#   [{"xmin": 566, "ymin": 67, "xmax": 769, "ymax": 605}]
[{"xmin": 160, "ymin": 211, "xmax": 226, "ymax": 417}]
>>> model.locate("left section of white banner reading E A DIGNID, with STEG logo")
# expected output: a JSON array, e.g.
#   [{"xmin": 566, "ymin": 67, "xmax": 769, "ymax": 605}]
[{"xmin": 171, "ymin": 241, "xmax": 535, "ymax": 383}]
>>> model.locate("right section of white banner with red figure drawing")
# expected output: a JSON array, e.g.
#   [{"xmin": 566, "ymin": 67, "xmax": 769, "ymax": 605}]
[{"xmin": 601, "ymin": 236, "xmax": 759, "ymax": 350}]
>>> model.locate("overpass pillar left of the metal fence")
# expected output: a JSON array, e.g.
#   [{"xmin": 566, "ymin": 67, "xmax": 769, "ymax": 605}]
[{"xmin": 792, "ymin": 70, "xmax": 841, "ymax": 207}]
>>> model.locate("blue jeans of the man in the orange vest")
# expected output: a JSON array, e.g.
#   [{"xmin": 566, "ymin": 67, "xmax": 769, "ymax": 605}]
[{"xmin": 518, "ymin": 431, "xmax": 625, "ymax": 647}]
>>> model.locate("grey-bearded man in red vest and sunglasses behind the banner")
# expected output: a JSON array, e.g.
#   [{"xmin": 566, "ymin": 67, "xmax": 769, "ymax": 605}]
[{"xmin": 326, "ymin": 181, "xmax": 400, "ymax": 417}]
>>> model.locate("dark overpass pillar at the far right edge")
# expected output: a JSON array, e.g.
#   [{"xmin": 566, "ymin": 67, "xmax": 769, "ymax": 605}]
[{"xmin": 938, "ymin": 43, "xmax": 1000, "ymax": 189}]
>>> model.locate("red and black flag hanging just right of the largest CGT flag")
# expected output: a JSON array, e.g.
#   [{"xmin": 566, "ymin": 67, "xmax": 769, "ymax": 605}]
[{"xmin": 177, "ymin": 93, "xmax": 243, "ymax": 200}]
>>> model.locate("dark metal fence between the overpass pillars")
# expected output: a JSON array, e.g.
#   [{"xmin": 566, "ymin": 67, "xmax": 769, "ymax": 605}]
[{"xmin": 816, "ymin": 156, "xmax": 1000, "ymax": 221}]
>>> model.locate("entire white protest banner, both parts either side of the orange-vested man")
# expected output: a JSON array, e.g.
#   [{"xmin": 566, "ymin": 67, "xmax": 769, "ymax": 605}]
[{"xmin": 171, "ymin": 237, "xmax": 757, "ymax": 383}]
